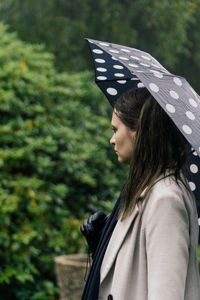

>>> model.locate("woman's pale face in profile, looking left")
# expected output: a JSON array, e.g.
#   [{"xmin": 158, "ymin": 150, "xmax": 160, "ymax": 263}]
[{"xmin": 110, "ymin": 110, "xmax": 136, "ymax": 164}]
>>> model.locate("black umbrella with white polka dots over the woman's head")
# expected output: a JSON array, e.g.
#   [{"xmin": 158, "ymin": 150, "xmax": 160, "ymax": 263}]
[{"xmin": 86, "ymin": 39, "xmax": 200, "ymax": 224}]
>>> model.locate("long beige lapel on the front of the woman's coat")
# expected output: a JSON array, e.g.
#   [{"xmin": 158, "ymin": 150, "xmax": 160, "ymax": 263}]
[{"xmin": 100, "ymin": 204, "xmax": 139, "ymax": 283}]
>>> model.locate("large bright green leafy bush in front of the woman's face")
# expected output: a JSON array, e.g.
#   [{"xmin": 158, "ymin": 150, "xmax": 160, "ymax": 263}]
[{"xmin": 0, "ymin": 24, "xmax": 125, "ymax": 300}]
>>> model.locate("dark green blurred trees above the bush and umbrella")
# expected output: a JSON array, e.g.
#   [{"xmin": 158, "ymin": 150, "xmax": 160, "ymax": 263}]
[{"xmin": 0, "ymin": 0, "xmax": 200, "ymax": 89}]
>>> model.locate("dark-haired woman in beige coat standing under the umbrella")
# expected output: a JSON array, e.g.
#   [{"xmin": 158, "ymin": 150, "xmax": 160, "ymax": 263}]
[{"xmin": 82, "ymin": 88, "xmax": 200, "ymax": 300}]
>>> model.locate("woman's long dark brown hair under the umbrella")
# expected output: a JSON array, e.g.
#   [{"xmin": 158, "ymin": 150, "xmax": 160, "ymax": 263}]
[{"xmin": 114, "ymin": 88, "xmax": 191, "ymax": 219}]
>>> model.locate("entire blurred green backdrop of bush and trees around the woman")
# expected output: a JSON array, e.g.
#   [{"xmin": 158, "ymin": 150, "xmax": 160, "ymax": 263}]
[{"xmin": 0, "ymin": 0, "xmax": 200, "ymax": 300}]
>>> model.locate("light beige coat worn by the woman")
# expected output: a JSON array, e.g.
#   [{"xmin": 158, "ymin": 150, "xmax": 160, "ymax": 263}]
[{"xmin": 99, "ymin": 177, "xmax": 200, "ymax": 300}]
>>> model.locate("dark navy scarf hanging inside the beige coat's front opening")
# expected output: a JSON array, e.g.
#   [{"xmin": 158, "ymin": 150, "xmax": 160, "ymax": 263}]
[{"xmin": 81, "ymin": 193, "xmax": 122, "ymax": 300}]
